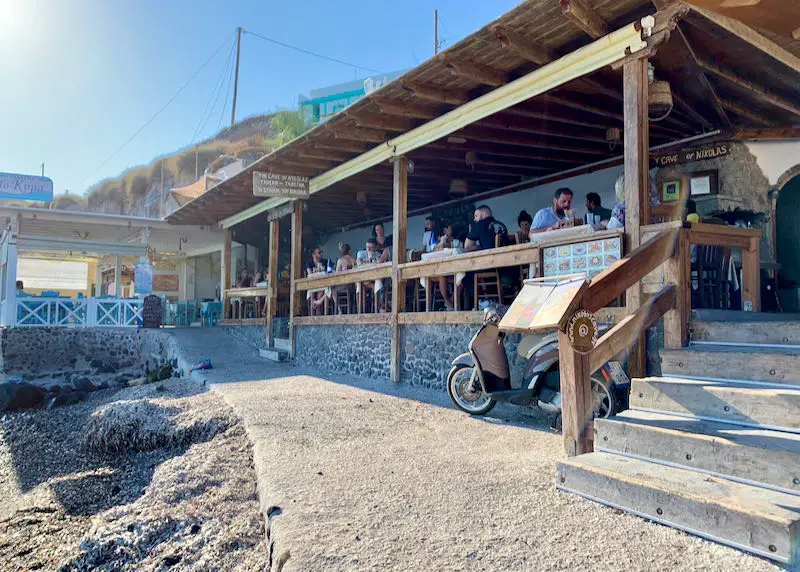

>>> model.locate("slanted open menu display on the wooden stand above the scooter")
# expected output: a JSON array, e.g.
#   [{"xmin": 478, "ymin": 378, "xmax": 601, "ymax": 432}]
[{"xmin": 499, "ymin": 275, "xmax": 588, "ymax": 333}]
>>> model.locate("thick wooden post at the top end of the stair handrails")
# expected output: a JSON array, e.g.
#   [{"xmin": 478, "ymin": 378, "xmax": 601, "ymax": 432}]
[{"xmin": 664, "ymin": 228, "xmax": 692, "ymax": 349}]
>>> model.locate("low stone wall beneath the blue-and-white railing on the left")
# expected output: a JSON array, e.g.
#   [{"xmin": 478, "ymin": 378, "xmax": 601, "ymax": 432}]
[{"xmin": 0, "ymin": 328, "xmax": 178, "ymax": 379}]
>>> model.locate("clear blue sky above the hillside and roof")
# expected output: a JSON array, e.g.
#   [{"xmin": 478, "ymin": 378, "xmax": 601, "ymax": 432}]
[{"xmin": 0, "ymin": 0, "xmax": 517, "ymax": 194}]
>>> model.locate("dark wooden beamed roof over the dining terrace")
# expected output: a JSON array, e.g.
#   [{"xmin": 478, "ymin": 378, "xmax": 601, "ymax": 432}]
[{"xmin": 168, "ymin": 0, "xmax": 800, "ymax": 231}]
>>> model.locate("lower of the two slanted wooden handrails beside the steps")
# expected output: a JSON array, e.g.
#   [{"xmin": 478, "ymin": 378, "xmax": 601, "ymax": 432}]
[{"xmin": 589, "ymin": 284, "xmax": 678, "ymax": 372}]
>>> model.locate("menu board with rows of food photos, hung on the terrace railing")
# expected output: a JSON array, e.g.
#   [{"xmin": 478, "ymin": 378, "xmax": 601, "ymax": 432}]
[{"xmin": 543, "ymin": 236, "xmax": 622, "ymax": 278}]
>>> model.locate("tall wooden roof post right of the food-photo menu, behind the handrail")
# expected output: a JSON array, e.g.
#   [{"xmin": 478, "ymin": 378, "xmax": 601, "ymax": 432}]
[{"xmin": 622, "ymin": 58, "xmax": 650, "ymax": 377}]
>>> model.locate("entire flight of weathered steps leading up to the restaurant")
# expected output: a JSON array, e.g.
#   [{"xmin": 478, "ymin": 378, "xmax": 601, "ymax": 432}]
[{"xmin": 556, "ymin": 313, "xmax": 800, "ymax": 568}]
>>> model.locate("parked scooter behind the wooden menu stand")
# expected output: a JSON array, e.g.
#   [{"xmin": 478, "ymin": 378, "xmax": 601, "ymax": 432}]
[{"xmin": 447, "ymin": 308, "xmax": 630, "ymax": 417}]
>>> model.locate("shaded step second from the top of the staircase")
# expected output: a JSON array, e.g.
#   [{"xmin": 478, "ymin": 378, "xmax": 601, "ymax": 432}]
[{"xmin": 661, "ymin": 343, "xmax": 800, "ymax": 387}]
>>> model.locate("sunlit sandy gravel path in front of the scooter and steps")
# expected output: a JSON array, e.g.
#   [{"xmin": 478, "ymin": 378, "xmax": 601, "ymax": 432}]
[{"xmin": 213, "ymin": 370, "xmax": 778, "ymax": 572}]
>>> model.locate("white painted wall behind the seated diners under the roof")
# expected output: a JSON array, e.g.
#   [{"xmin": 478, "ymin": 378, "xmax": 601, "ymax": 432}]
[{"xmin": 322, "ymin": 166, "xmax": 622, "ymax": 259}]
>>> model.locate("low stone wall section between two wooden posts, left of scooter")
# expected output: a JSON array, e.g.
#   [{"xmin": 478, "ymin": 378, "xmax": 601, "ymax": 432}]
[{"xmin": 295, "ymin": 324, "xmax": 392, "ymax": 380}]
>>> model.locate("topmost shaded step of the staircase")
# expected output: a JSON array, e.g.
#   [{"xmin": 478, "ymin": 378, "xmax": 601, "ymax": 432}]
[{"xmin": 691, "ymin": 312, "xmax": 800, "ymax": 346}]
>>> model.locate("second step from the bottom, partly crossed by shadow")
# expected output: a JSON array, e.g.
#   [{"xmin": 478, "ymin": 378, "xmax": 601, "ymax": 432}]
[{"xmin": 594, "ymin": 411, "xmax": 800, "ymax": 495}]
